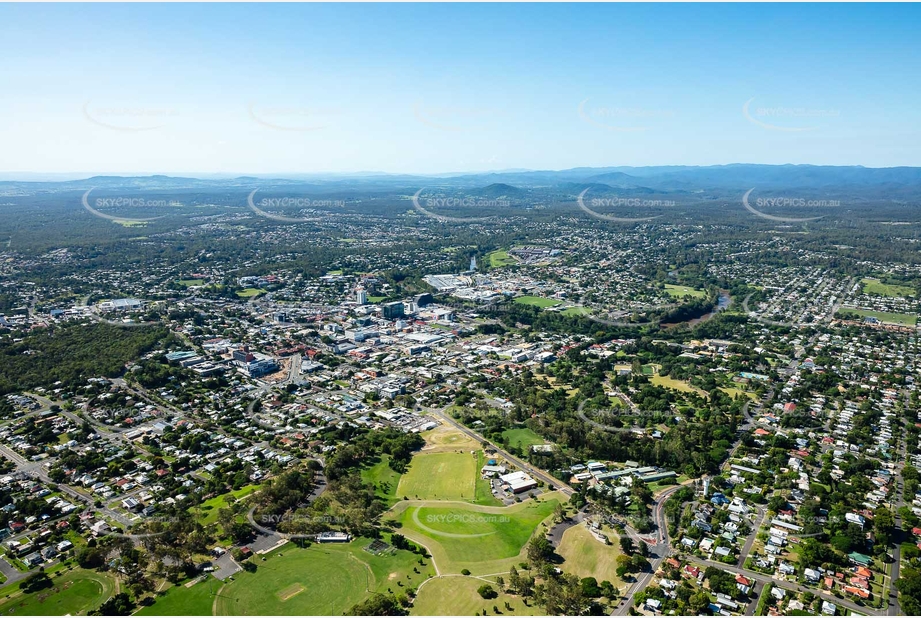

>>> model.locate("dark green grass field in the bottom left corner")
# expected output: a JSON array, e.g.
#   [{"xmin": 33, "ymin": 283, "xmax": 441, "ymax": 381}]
[{"xmin": 0, "ymin": 569, "xmax": 115, "ymax": 616}]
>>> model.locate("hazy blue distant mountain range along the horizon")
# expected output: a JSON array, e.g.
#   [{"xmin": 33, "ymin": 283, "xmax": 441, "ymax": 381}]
[{"xmin": 0, "ymin": 164, "xmax": 921, "ymax": 197}]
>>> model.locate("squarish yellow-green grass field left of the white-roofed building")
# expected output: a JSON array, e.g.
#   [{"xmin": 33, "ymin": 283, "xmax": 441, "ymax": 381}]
[{"xmin": 396, "ymin": 451, "xmax": 477, "ymax": 500}]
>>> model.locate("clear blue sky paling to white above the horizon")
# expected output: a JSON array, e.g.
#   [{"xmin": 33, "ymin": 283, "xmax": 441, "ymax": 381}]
[{"xmin": 0, "ymin": 4, "xmax": 921, "ymax": 177}]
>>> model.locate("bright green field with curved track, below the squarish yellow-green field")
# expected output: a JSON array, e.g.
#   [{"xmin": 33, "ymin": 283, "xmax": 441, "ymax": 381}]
[{"xmin": 392, "ymin": 492, "xmax": 561, "ymax": 574}]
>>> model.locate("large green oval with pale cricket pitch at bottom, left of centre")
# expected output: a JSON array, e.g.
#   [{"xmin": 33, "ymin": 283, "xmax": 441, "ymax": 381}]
[{"xmin": 216, "ymin": 539, "xmax": 434, "ymax": 616}]
